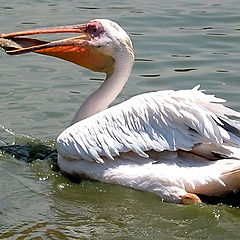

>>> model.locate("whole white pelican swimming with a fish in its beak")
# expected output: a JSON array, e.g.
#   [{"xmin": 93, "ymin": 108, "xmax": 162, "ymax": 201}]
[{"xmin": 0, "ymin": 19, "xmax": 240, "ymax": 204}]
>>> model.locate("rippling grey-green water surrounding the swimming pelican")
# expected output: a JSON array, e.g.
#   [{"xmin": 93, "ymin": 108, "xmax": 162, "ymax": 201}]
[{"xmin": 0, "ymin": 0, "xmax": 240, "ymax": 240}]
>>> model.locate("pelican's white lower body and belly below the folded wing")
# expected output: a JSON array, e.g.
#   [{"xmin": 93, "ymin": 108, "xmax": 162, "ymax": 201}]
[{"xmin": 59, "ymin": 152, "xmax": 240, "ymax": 203}]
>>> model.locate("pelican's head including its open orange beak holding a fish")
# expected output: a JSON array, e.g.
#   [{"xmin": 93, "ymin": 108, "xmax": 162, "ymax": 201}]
[{"xmin": 0, "ymin": 19, "xmax": 134, "ymax": 76}]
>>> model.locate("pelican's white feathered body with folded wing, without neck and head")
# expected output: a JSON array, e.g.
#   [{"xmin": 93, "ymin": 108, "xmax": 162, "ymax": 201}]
[{"xmin": 57, "ymin": 87, "xmax": 240, "ymax": 202}]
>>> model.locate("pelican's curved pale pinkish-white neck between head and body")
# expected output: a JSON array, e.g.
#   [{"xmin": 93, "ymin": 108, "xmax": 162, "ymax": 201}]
[{"xmin": 71, "ymin": 48, "xmax": 134, "ymax": 124}]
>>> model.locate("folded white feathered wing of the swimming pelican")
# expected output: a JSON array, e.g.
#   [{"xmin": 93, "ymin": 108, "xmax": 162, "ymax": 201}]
[{"xmin": 57, "ymin": 86, "xmax": 240, "ymax": 162}]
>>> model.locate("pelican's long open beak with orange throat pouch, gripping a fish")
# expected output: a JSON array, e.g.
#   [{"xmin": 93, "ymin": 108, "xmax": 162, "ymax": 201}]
[{"xmin": 0, "ymin": 24, "xmax": 114, "ymax": 74}]
